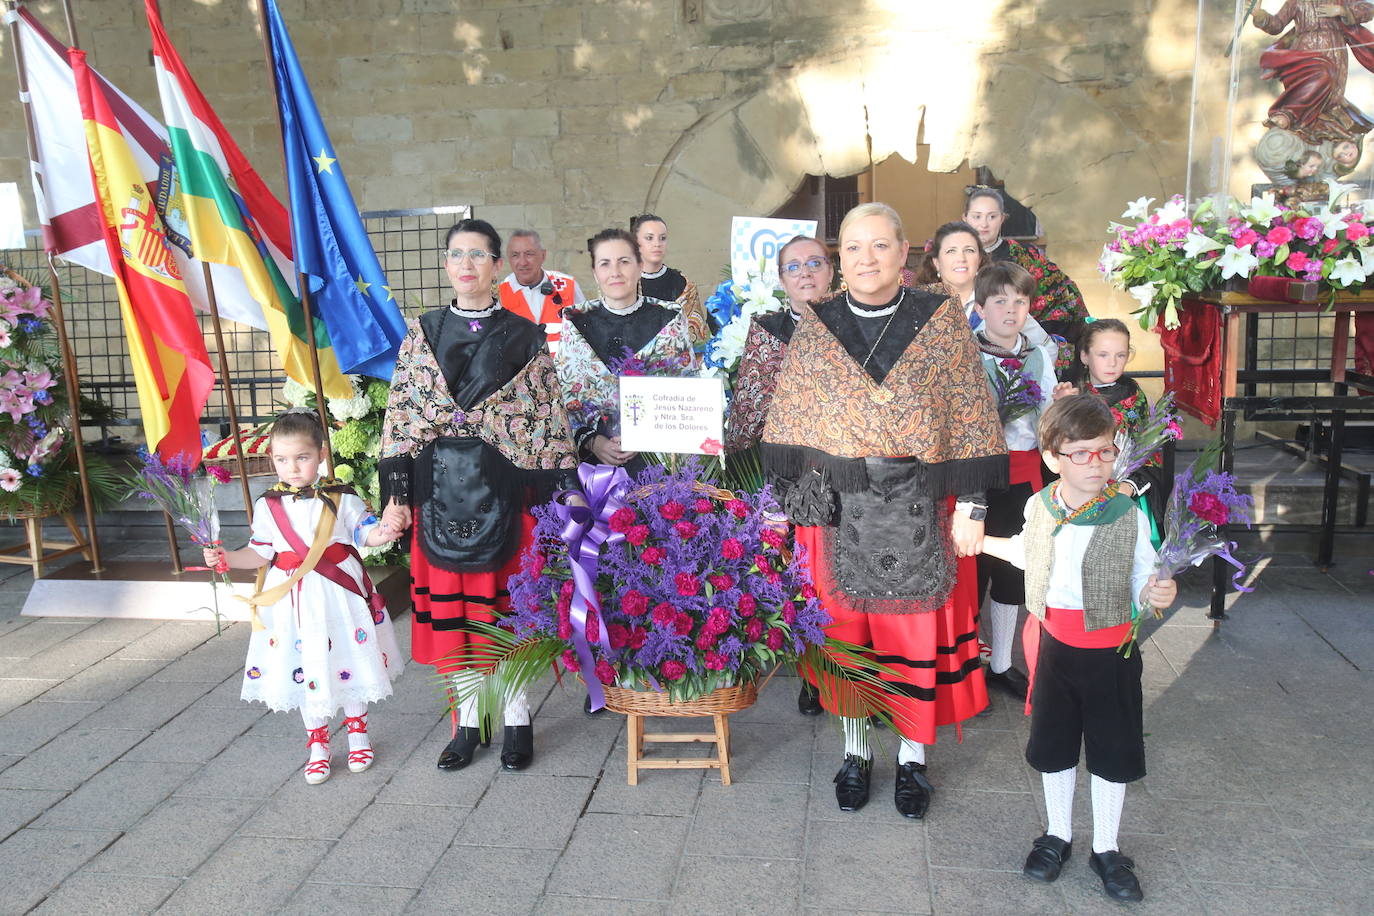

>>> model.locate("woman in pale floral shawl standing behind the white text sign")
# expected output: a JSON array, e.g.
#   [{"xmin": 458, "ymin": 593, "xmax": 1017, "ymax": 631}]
[{"xmin": 556, "ymin": 229, "xmax": 697, "ymax": 477}]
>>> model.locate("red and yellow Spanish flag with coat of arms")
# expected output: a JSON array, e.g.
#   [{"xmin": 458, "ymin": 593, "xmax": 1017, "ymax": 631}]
[{"xmin": 70, "ymin": 49, "xmax": 214, "ymax": 467}]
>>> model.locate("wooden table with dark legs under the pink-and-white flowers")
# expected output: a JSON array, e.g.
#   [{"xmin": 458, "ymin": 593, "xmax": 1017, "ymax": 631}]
[{"xmin": 1183, "ymin": 291, "xmax": 1374, "ymax": 621}]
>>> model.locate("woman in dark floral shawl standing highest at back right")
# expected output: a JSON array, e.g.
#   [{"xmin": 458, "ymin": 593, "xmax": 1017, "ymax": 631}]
[{"xmin": 963, "ymin": 188, "xmax": 1088, "ymax": 378}]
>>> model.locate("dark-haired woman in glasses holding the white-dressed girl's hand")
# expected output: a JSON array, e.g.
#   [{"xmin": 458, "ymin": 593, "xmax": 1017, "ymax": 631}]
[{"xmin": 378, "ymin": 220, "xmax": 577, "ymax": 769}]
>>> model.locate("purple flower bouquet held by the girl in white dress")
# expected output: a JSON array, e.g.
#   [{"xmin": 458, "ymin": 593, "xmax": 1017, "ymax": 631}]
[{"xmin": 126, "ymin": 448, "xmax": 234, "ymax": 634}]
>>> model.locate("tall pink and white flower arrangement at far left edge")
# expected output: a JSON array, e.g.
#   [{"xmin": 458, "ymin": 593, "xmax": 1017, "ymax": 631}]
[{"xmin": 0, "ymin": 268, "xmax": 120, "ymax": 518}]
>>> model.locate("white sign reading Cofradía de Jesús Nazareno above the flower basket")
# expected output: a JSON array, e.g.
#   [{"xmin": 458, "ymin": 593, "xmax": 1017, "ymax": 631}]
[{"xmin": 620, "ymin": 375, "xmax": 725, "ymax": 455}]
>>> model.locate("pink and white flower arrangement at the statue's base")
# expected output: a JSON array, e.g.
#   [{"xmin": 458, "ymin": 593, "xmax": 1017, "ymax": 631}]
[{"xmin": 1098, "ymin": 183, "xmax": 1374, "ymax": 330}]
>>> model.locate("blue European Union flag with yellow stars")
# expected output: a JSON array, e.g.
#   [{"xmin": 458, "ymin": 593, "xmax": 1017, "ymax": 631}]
[{"xmin": 262, "ymin": 0, "xmax": 405, "ymax": 379}]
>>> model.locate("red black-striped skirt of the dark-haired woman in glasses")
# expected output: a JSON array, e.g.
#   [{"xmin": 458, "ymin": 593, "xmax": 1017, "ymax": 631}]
[{"xmin": 411, "ymin": 512, "xmax": 534, "ymax": 673}]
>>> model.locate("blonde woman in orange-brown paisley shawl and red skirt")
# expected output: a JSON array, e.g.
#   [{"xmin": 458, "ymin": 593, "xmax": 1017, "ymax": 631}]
[{"xmin": 761, "ymin": 203, "xmax": 1007, "ymax": 817}]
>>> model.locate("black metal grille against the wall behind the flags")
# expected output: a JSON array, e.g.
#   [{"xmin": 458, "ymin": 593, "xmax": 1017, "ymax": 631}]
[{"xmin": 0, "ymin": 206, "xmax": 471, "ymax": 435}]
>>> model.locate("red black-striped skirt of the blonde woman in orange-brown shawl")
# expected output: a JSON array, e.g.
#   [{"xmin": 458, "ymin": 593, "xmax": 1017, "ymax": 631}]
[{"xmin": 797, "ymin": 527, "xmax": 988, "ymax": 744}]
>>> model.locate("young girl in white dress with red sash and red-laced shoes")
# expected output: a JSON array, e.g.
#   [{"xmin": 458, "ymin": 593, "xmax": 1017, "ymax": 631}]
[{"xmin": 205, "ymin": 412, "xmax": 407, "ymax": 786}]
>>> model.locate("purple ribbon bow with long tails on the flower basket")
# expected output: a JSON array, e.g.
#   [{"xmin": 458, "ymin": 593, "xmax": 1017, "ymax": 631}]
[{"xmin": 554, "ymin": 464, "xmax": 629, "ymax": 711}]
